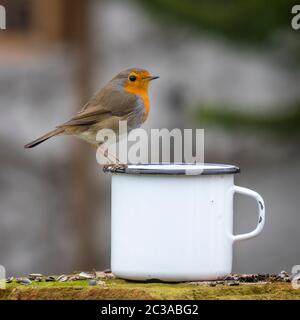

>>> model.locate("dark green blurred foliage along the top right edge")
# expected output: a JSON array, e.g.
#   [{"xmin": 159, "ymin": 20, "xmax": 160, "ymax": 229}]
[{"xmin": 139, "ymin": 0, "xmax": 296, "ymax": 42}]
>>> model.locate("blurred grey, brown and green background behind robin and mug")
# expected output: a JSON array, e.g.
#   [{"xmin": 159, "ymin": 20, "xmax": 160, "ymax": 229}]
[{"xmin": 0, "ymin": 0, "xmax": 300, "ymax": 275}]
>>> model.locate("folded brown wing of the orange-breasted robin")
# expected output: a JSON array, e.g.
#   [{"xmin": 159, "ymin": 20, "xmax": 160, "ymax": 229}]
[{"xmin": 59, "ymin": 87, "xmax": 136, "ymax": 127}]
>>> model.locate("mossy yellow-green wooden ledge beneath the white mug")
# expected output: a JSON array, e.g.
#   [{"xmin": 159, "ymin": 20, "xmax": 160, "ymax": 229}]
[{"xmin": 0, "ymin": 279, "xmax": 300, "ymax": 300}]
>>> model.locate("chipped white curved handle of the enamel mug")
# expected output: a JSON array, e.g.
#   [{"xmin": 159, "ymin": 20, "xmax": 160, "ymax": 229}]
[{"xmin": 232, "ymin": 186, "xmax": 265, "ymax": 242}]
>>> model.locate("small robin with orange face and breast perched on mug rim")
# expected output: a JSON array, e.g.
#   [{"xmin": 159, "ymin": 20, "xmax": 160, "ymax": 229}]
[{"xmin": 25, "ymin": 68, "xmax": 158, "ymax": 161}]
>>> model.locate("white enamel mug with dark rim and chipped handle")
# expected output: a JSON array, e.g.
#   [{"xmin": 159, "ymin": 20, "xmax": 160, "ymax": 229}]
[{"xmin": 105, "ymin": 164, "xmax": 265, "ymax": 281}]
